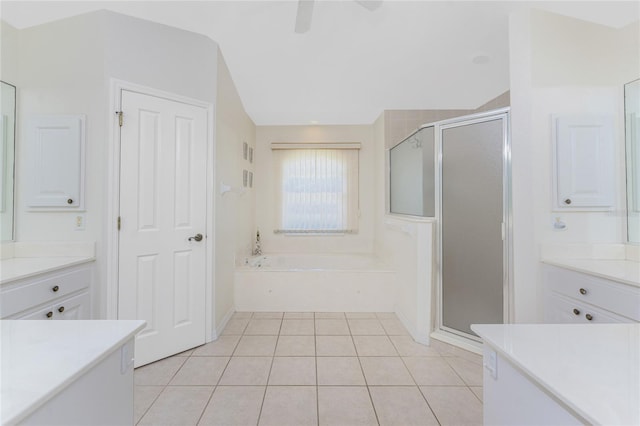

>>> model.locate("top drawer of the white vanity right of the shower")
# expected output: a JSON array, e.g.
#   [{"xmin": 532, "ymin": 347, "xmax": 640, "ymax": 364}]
[{"xmin": 544, "ymin": 265, "xmax": 640, "ymax": 321}]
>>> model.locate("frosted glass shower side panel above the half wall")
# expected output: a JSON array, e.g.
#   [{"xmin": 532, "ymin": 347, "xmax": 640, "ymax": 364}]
[{"xmin": 389, "ymin": 127, "xmax": 435, "ymax": 217}]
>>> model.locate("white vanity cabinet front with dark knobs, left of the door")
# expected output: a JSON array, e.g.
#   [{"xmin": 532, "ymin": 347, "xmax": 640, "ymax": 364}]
[{"xmin": 0, "ymin": 264, "xmax": 91, "ymax": 320}]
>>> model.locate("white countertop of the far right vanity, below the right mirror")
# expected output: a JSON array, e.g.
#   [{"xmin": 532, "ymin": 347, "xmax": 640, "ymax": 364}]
[{"xmin": 542, "ymin": 259, "xmax": 640, "ymax": 287}]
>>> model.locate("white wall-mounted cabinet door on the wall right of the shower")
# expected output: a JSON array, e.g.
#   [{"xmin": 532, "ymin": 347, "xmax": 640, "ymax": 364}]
[{"xmin": 554, "ymin": 116, "xmax": 615, "ymax": 210}]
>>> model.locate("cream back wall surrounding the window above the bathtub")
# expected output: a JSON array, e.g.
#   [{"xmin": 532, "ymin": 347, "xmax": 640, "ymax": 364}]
[{"xmin": 254, "ymin": 125, "xmax": 376, "ymax": 253}]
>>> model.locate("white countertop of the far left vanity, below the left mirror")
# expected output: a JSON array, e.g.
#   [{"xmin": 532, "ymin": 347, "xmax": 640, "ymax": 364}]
[{"xmin": 0, "ymin": 256, "xmax": 95, "ymax": 284}]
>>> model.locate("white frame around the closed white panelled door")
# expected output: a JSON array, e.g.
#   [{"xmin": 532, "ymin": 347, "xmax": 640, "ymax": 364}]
[{"xmin": 104, "ymin": 78, "xmax": 217, "ymax": 342}]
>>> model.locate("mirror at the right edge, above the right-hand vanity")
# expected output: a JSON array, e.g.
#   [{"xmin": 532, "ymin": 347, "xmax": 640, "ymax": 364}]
[{"xmin": 624, "ymin": 79, "xmax": 640, "ymax": 244}]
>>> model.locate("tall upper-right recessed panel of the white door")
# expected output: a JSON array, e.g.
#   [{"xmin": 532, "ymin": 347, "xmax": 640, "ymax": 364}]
[{"xmin": 174, "ymin": 117, "xmax": 193, "ymax": 228}]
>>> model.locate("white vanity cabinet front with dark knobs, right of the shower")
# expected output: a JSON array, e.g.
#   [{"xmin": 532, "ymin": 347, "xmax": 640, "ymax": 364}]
[{"xmin": 542, "ymin": 264, "xmax": 640, "ymax": 324}]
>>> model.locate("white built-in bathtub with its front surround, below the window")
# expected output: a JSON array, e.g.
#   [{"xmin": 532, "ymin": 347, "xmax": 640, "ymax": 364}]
[{"xmin": 234, "ymin": 253, "xmax": 396, "ymax": 312}]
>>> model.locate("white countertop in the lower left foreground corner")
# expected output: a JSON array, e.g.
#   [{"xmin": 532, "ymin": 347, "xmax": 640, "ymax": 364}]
[{"xmin": 0, "ymin": 320, "xmax": 145, "ymax": 424}]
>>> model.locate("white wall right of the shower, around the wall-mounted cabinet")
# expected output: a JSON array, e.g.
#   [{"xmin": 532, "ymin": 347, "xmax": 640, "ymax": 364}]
[{"xmin": 509, "ymin": 10, "xmax": 640, "ymax": 322}]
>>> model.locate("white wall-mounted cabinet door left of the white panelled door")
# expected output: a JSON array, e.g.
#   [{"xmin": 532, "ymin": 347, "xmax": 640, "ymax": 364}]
[{"xmin": 26, "ymin": 115, "xmax": 85, "ymax": 208}]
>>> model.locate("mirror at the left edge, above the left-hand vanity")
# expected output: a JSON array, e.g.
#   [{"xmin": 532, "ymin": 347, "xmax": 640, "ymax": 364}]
[{"xmin": 0, "ymin": 81, "xmax": 16, "ymax": 241}]
